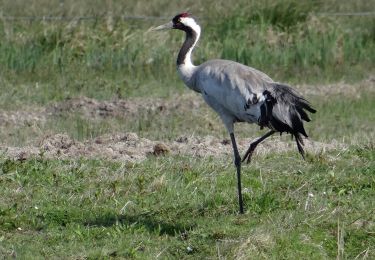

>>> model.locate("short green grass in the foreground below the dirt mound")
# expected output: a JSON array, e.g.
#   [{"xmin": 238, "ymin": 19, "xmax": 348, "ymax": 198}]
[{"xmin": 0, "ymin": 146, "xmax": 375, "ymax": 259}]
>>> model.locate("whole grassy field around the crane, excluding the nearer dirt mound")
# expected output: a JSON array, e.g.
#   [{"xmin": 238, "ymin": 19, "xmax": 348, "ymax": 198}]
[{"xmin": 0, "ymin": 0, "xmax": 375, "ymax": 259}]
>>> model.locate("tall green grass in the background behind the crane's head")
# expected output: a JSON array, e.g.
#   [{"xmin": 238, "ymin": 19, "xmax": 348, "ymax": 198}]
[{"xmin": 0, "ymin": 0, "xmax": 375, "ymax": 106}]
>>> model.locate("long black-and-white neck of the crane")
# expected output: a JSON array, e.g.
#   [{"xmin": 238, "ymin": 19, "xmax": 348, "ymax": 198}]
[{"xmin": 177, "ymin": 27, "xmax": 200, "ymax": 66}]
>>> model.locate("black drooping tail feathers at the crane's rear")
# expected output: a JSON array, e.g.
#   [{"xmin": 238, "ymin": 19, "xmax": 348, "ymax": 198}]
[{"xmin": 265, "ymin": 83, "xmax": 316, "ymax": 157}]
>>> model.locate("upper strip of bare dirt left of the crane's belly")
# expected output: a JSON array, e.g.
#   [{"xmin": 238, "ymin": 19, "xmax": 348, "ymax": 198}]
[{"xmin": 0, "ymin": 93, "xmax": 205, "ymax": 127}]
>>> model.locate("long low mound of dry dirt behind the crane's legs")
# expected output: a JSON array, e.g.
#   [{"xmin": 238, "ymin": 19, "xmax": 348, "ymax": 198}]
[{"xmin": 0, "ymin": 133, "xmax": 345, "ymax": 162}]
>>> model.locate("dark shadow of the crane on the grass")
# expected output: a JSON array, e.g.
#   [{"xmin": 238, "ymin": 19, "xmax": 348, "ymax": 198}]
[{"xmin": 84, "ymin": 214, "xmax": 196, "ymax": 236}]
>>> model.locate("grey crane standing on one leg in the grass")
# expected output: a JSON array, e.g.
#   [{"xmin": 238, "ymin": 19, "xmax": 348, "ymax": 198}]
[{"xmin": 154, "ymin": 13, "xmax": 316, "ymax": 214}]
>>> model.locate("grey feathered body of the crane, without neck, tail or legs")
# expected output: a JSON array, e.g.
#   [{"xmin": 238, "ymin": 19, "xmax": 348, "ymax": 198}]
[{"xmin": 193, "ymin": 60, "xmax": 273, "ymax": 132}]
